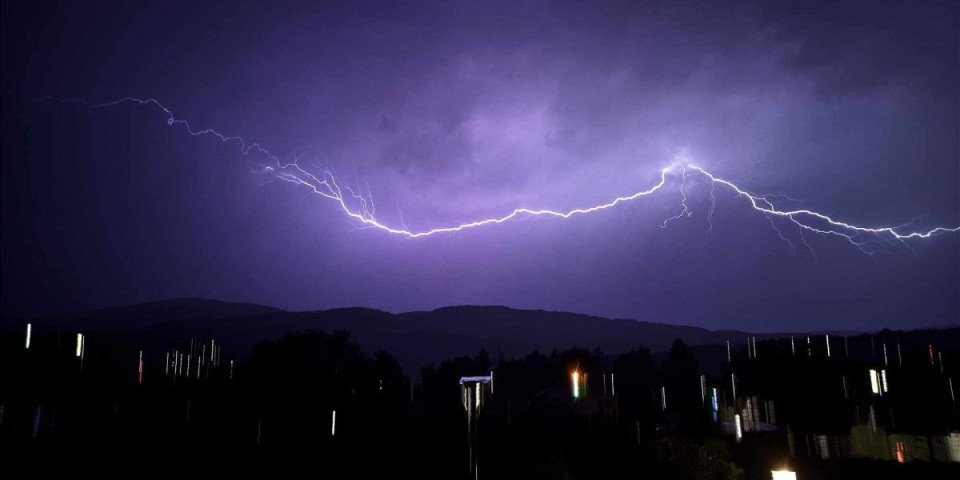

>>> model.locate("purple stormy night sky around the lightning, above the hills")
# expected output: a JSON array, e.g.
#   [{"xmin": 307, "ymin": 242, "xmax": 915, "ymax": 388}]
[{"xmin": 0, "ymin": 0, "xmax": 960, "ymax": 331}]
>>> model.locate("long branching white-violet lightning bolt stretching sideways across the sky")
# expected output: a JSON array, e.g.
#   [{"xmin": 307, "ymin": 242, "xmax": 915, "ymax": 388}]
[{"xmin": 44, "ymin": 97, "xmax": 960, "ymax": 248}]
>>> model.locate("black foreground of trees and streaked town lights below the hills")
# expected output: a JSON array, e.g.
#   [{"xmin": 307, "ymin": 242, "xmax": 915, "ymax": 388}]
[{"xmin": 0, "ymin": 332, "xmax": 960, "ymax": 480}]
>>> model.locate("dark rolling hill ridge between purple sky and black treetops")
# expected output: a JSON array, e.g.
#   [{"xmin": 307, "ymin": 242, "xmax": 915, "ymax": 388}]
[{"xmin": 11, "ymin": 299, "xmax": 944, "ymax": 376}]
